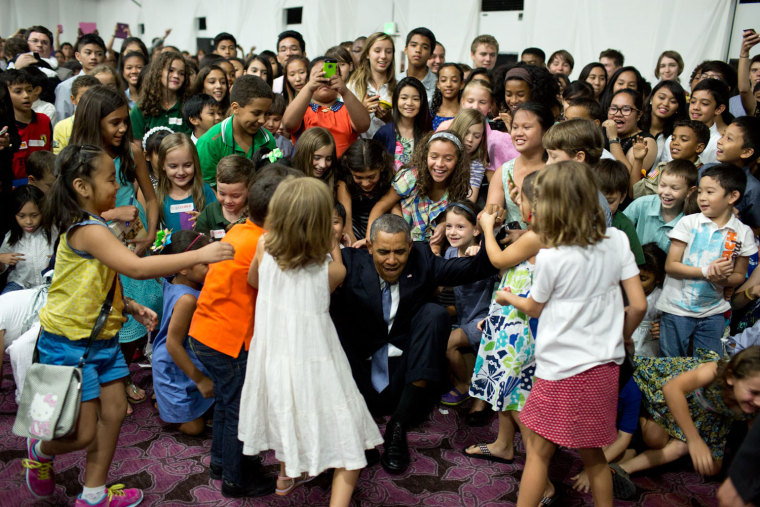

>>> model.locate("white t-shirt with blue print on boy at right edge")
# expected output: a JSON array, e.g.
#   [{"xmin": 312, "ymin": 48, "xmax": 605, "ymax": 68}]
[{"xmin": 657, "ymin": 213, "xmax": 757, "ymax": 318}]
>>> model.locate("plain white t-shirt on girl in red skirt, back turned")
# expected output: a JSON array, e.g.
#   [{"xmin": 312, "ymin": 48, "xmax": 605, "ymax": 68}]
[{"xmin": 530, "ymin": 227, "xmax": 639, "ymax": 380}]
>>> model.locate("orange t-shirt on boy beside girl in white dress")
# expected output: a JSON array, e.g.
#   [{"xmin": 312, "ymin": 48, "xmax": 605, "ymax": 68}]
[{"xmin": 188, "ymin": 220, "xmax": 264, "ymax": 357}]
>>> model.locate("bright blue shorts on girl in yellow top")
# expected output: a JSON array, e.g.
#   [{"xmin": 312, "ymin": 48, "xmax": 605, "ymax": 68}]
[{"xmin": 37, "ymin": 330, "xmax": 129, "ymax": 401}]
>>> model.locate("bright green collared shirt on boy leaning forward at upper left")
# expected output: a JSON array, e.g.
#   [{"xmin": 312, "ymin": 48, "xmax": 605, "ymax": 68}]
[{"xmin": 195, "ymin": 115, "xmax": 277, "ymax": 188}]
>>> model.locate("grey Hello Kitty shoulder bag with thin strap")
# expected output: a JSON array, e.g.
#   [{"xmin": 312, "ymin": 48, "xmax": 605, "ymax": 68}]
[{"xmin": 13, "ymin": 277, "xmax": 117, "ymax": 440}]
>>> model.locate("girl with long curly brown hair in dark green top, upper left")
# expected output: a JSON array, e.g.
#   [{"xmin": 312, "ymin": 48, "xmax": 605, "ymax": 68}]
[{"xmin": 131, "ymin": 52, "xmax": 192, "ymax": 142}]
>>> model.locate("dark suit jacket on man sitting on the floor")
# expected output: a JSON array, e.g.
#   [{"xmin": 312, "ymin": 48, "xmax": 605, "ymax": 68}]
[{"xmin": 330, "ymin": 242, "xmax": 496, "ymax": 362}]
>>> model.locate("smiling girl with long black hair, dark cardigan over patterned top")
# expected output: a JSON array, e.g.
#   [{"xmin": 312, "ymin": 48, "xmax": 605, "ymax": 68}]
[{"xmin": 372, "ymin": 77, "xmax": 432, "ymax": 171}]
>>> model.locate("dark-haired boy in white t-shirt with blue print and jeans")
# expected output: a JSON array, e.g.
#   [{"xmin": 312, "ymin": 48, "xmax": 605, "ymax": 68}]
[{"xmin": 657, "ymin": 164, "xmax": 757, "ymax": 357}]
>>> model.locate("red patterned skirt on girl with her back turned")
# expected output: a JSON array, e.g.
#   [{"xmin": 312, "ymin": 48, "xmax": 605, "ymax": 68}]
[{"xmin": 520, "ymin": 363, "xmax": 620, "ymax": 449}]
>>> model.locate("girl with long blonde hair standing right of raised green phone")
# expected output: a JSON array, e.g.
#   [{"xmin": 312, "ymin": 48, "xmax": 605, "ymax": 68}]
[{"xmin": 347, "ymin": 32, "xmax": 396, "ymax": 139}]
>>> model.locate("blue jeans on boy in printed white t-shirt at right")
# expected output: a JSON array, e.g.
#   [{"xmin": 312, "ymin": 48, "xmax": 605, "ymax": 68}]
[{"xmin": 660, "ymin": 313, "xmax": 726, "ymax": 357}]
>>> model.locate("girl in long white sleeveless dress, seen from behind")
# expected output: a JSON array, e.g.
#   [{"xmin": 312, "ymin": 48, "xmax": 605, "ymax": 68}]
[{"xmin": 238, "ymin": 178, "xmax": 383, "ymax": 505}]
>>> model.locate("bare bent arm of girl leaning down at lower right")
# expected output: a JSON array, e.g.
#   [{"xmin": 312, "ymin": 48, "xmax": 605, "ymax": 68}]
[{"xmin": 662, "ymin": 363, "xmax": 718, "ymax": 475}]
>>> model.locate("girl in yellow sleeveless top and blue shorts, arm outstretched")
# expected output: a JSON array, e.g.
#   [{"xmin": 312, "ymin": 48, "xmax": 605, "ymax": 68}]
[{"xmin": 24, "ymin": 145, "xmax": 234, "ymax": 507}]
